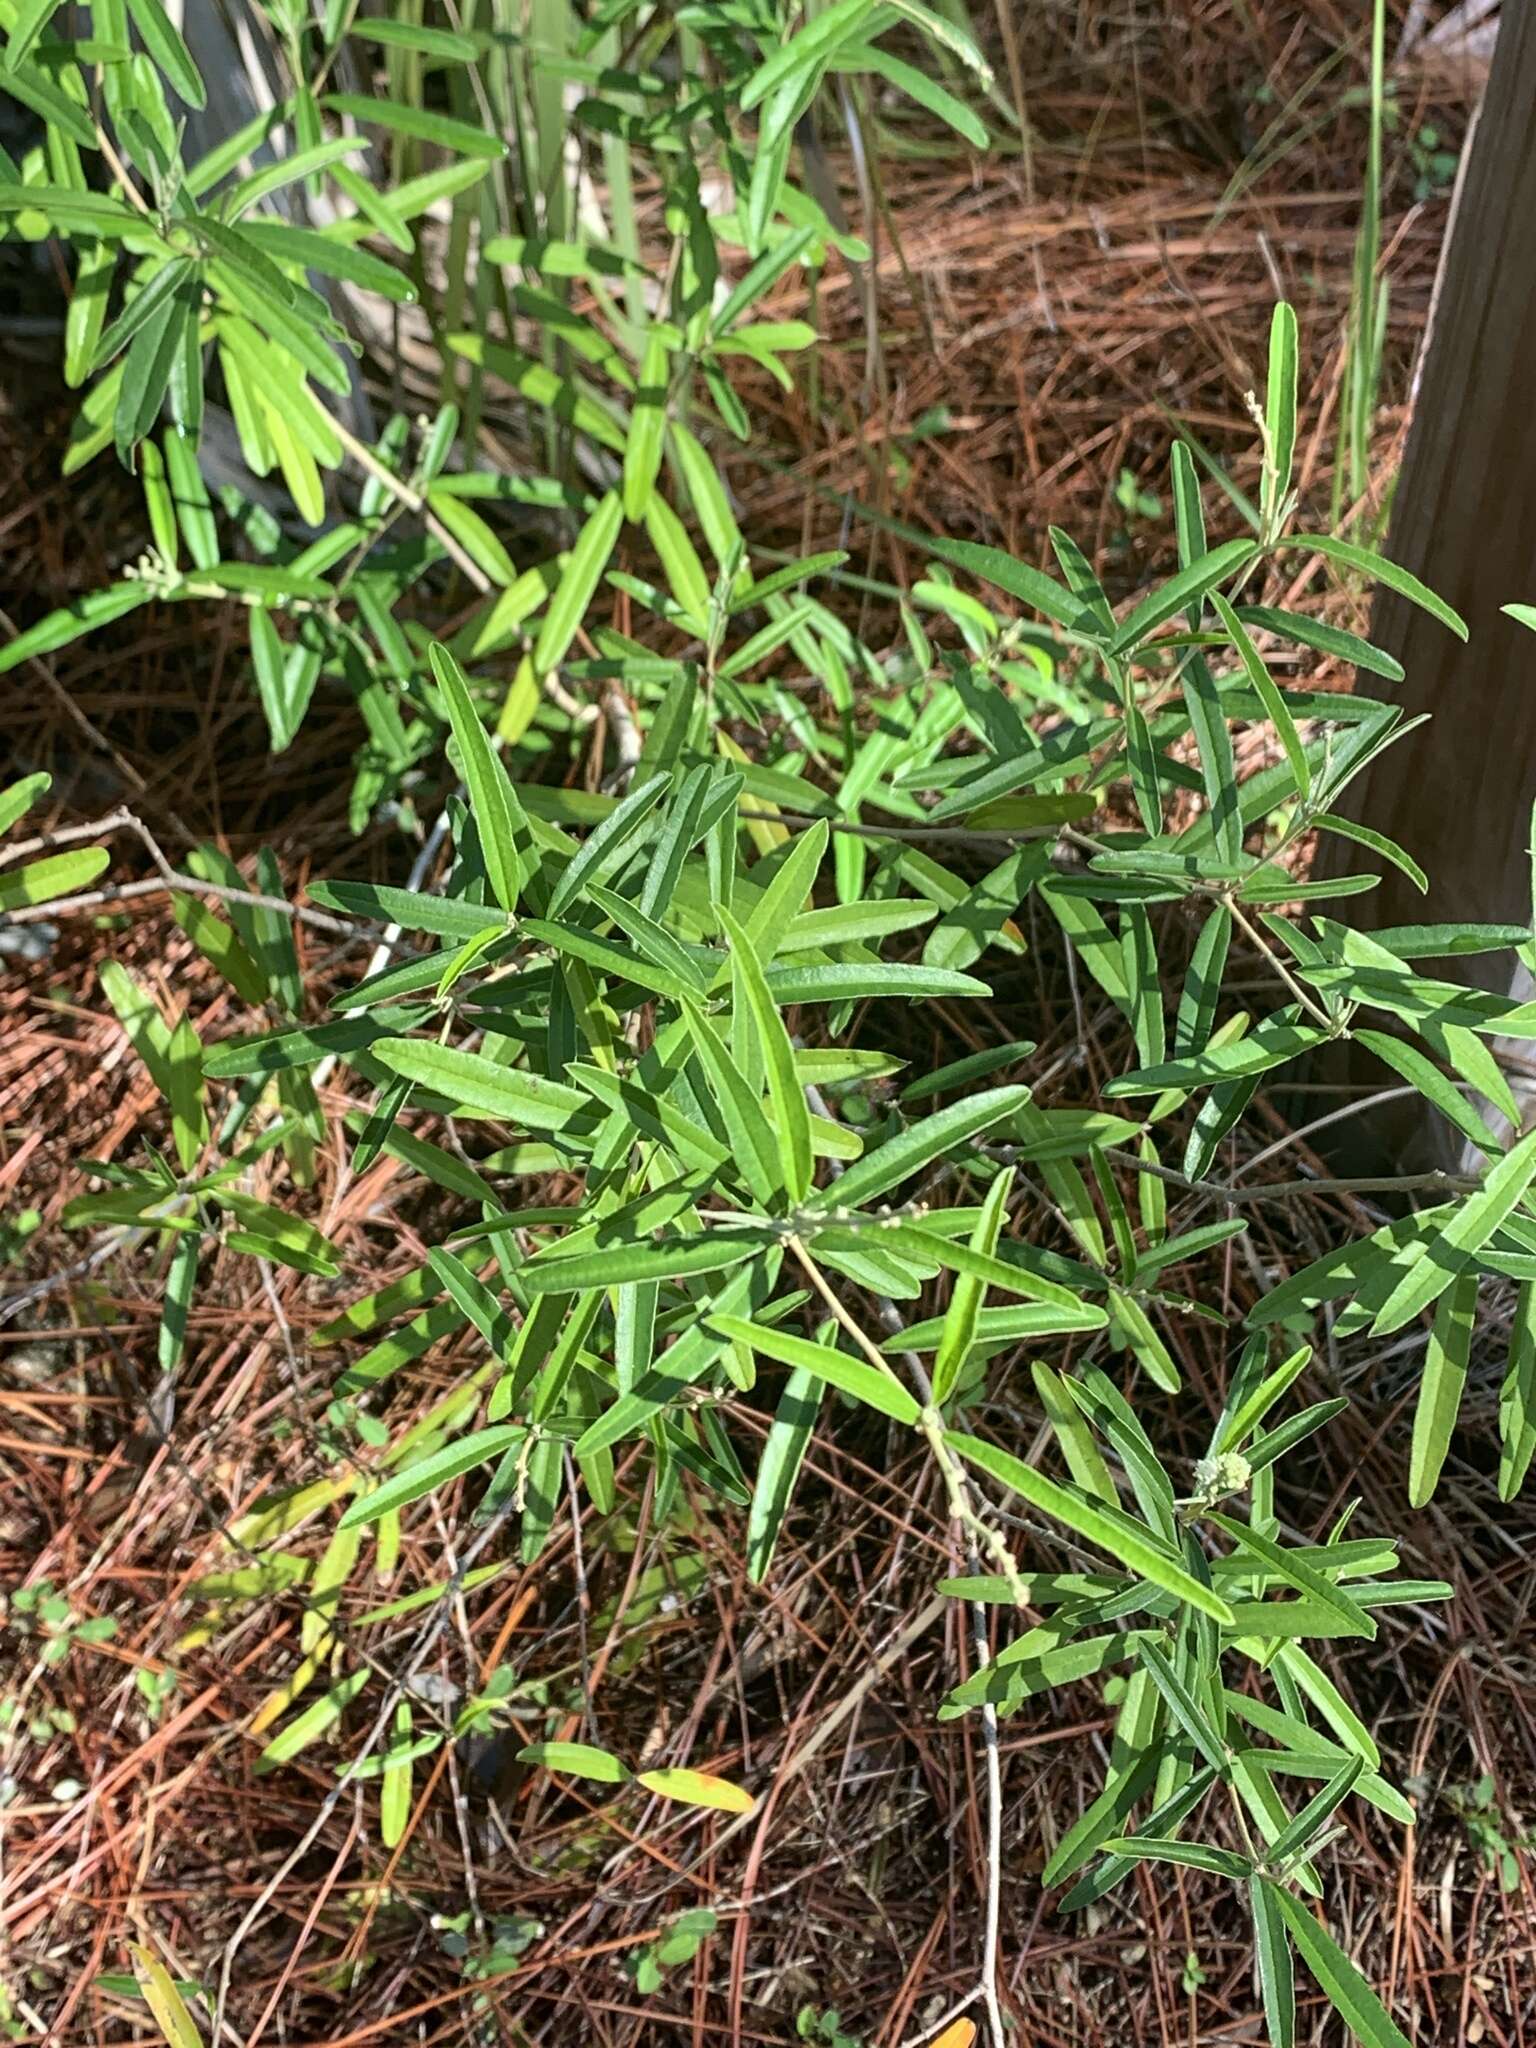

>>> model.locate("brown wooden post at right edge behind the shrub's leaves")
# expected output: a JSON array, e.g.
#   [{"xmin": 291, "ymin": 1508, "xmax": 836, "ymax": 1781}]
[{"xmin": 1317, "ymin": 0, "xmax": 1536, "ymax": 1157}]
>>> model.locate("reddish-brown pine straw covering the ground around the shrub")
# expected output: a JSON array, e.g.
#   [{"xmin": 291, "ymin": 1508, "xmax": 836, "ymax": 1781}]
[{"xmin": 0, "ymin": 0, "xmax": 1536, "ymax": 2048}]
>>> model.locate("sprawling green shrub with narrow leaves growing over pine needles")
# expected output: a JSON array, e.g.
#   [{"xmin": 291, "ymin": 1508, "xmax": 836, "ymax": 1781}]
[{"xmin": 0, "ymin": 0, "xmax": 1536, "ymax": 2048}]
